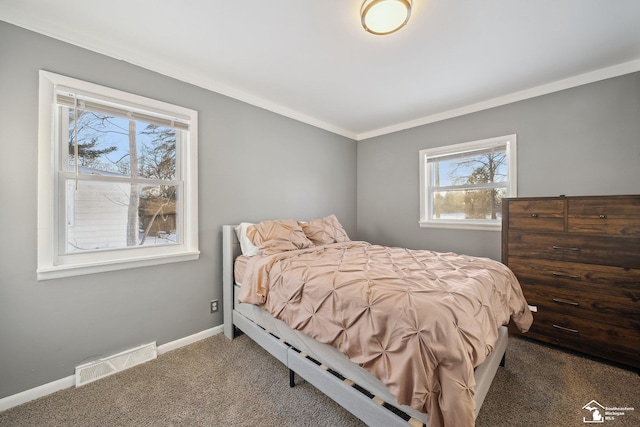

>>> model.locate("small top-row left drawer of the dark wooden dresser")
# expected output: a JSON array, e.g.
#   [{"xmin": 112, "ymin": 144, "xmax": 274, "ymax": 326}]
[{"xmin": 507, "ymin": 200, "xmax": 564, "ymax": 231}]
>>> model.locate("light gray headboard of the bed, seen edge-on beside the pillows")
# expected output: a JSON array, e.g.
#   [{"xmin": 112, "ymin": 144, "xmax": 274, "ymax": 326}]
[{"xmin": 222, "ymin": 225, "xmax": 242, "ymax": 339}]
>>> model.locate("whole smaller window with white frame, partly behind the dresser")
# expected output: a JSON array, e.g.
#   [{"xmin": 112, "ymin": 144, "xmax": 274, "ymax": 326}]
[{"xmin": 420, "ymin": 135, "xmax": 517, "ymax": 230}]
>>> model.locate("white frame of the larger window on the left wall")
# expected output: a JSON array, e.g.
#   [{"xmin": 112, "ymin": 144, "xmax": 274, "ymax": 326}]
[{"xmin": 37, "ymin": 70, "xmax": 200, "ymax": 280}]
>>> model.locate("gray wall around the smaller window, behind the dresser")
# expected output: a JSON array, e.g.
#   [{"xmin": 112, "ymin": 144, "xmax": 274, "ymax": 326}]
[{"xmin": 357, "ymin": 73, "xmax": 640, "ymax": 260}]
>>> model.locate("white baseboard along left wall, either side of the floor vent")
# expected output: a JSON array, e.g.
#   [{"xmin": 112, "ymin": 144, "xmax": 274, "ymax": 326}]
[{"xmin": 0, "ymin": 325, "xmax": 223, "ymax": 411}]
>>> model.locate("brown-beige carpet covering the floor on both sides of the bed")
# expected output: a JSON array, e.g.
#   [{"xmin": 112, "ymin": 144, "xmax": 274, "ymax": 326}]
[{"xmin": 0, "ymin": 334, "xmax": 640, "ymax": 427}]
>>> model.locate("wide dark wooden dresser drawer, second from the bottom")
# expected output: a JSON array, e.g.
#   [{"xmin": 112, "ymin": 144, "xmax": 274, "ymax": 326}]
[{"xmin": 522, "ymin": 283, "xmax": 640, "ymax": 331}]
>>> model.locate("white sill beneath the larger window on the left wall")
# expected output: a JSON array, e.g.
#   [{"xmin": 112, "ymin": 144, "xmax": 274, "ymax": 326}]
[{"xmin": 37, "ymin": 251, "xmax": 200, "ymax": 280}]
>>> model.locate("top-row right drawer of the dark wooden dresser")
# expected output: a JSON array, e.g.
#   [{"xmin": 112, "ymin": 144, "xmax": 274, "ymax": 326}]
[{"xmin": 567, "ymin": 197, "xmax": 640, "ymax": 237}]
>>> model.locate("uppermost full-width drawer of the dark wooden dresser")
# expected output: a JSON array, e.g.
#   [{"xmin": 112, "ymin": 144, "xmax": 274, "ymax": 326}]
[{"xmin": 507, "ymin": 230, "xmax": 640, "ymax": 268}]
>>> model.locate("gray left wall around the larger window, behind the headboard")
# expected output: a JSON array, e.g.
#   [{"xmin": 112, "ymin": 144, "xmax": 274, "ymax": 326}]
[{"xmin": 0, "ymin": 22, "xmax": 357, "ymax": 398}]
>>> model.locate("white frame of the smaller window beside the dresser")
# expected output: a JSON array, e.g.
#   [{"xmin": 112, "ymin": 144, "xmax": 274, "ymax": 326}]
[{"xmin": 419, "ymin": 134, "xmax": 518, "ymax": 231}]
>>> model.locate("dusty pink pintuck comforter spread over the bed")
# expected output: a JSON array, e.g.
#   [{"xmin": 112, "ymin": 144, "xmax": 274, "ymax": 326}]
[{"xmin": 240, "ymin": 242, "xmax": 532, "ymax": 427}]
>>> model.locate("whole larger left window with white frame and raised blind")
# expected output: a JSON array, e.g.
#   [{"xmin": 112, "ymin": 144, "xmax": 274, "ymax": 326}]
[{"xmin": 38, "ymin": 71, "xmax": 198, "ymax": 279}]
